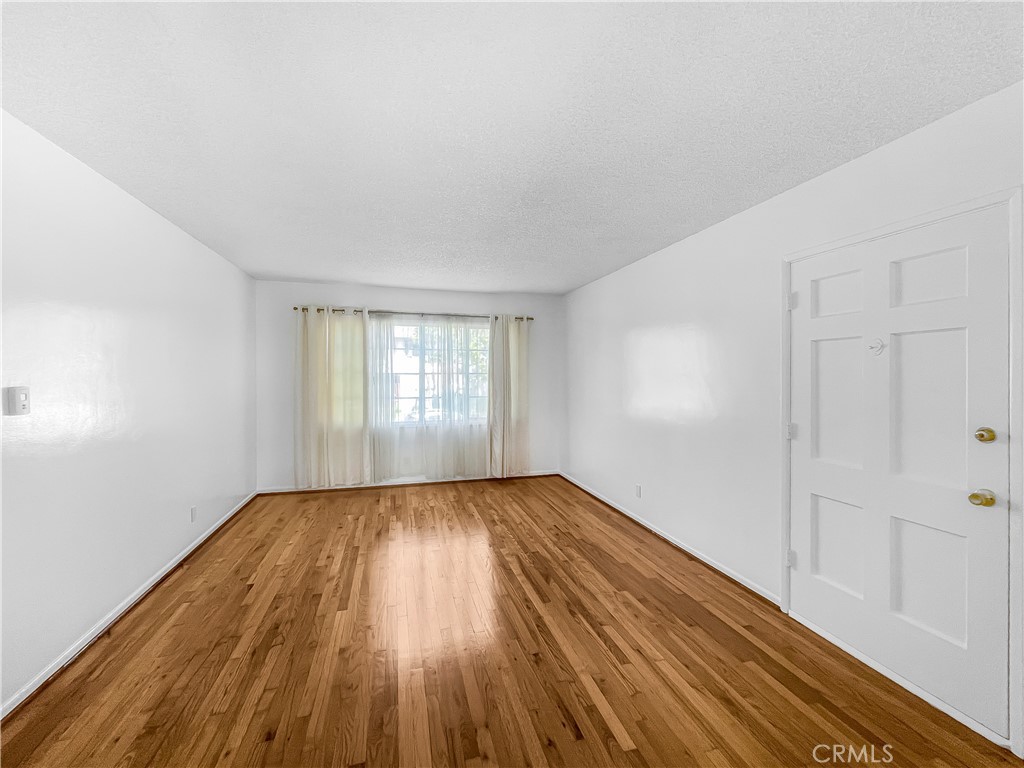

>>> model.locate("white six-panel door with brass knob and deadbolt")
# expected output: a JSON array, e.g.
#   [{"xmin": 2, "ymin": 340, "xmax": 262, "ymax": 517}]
[{"xmin": 791, "ymin": 206, "xmax": 1010, "ymax": 736}]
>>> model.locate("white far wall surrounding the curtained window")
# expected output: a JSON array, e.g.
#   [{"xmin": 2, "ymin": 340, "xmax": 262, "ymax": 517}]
[{"xmin": 255, "ymin": 281, "xmax": 565, "ymax": 490}]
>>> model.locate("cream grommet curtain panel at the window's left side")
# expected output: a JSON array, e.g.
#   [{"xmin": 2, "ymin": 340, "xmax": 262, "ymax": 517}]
[{"xmin": 295, "ymin": 307, "xmax": 370, "ymax": 488}]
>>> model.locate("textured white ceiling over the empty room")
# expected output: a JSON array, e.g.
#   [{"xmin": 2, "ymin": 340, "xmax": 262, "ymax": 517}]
[{"xmin": 3, "ymin": 3, "xmax": 1021, "ymax": 293}]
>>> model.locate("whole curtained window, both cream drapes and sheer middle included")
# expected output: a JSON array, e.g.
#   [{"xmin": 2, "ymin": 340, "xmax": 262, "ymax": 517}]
[{"xmin": 295, "ymin": 307, "xmax": 529, "ymax": 487}]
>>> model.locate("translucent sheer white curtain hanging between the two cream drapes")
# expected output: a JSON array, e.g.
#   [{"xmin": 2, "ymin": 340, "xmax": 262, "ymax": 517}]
[{"xmin": 367, "ymin": 313, "xmax": 488, "ymax": 482}]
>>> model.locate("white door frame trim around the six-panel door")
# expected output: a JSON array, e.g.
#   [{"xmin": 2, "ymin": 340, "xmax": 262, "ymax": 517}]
[{"xmin": 779, "ymin": 186, "xmax": 1024, "ymax": 757}]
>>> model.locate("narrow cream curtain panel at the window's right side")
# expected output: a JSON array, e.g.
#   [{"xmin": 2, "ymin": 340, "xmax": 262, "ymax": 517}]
[{"xmin": 487, "ymin": 314, "xmax": 529, "ymax": 477}]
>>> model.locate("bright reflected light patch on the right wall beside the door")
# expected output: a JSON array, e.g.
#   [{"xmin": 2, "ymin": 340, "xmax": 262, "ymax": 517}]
[{"xmin": 625, "ymin": 325, "xmax": 717, "ymax": 424}]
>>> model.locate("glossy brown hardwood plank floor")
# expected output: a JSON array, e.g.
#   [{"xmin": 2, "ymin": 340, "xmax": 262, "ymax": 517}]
[{"xmin": 2, "ymin": 477, "xmax": 1019, "ymax": 768}]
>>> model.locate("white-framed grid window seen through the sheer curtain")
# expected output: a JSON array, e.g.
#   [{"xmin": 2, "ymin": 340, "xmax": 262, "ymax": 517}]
[{"xmin": 390, "ymin": 315, "xmax": 490, "ymax": 425}]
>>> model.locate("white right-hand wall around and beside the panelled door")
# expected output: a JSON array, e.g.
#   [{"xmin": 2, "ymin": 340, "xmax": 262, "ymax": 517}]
[{"xmin": 565, "ymin": 84, "xmax": 1024, "ymax": 597}]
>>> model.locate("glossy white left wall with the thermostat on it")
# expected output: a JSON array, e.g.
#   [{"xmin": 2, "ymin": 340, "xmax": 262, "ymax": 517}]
[{"xmin": 2, "ymin": 113, "xmax": 256, "ymax": 711}]
